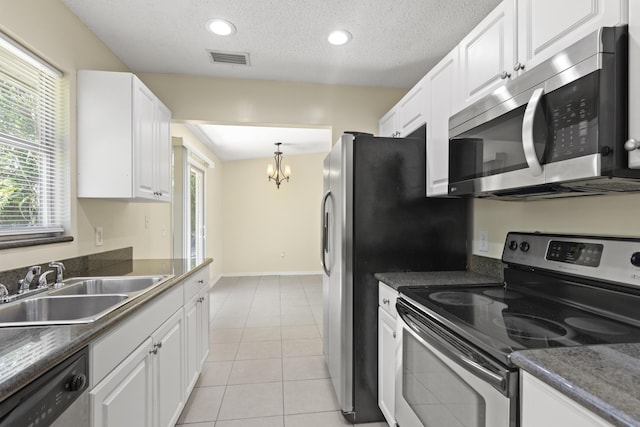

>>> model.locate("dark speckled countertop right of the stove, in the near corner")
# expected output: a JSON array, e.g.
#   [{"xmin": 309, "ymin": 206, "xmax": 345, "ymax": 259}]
[{"xmin": 511, "ymin": 344, "xmax": 640, "ymax": 427}]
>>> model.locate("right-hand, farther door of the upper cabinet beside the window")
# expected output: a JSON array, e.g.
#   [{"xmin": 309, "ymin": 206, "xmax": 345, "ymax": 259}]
[{"xmin": 155, "ymin": 101, "xmax": 171, "ymax": 202}]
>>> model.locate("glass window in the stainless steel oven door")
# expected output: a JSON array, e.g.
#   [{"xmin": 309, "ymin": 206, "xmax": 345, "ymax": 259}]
[{"xmin": 402, "ymin": 331, "xmax": 487, "ymax": 427}]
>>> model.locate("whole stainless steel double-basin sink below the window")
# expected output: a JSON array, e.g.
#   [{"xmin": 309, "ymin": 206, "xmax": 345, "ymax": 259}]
[{"xmin": 0, "ymin": 276, "xmax": 172, "ymax": 327}]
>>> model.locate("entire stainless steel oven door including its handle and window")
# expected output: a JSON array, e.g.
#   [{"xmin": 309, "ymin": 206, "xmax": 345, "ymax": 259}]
[{"xmin": 396, "ymin": 299, "xmax": 517, "ymax": 427}]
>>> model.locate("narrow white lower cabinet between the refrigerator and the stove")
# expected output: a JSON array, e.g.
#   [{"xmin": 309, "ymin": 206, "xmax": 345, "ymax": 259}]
[{"xmin": 378, "ymin": 282, "xmax": 399, "ymax": 426}]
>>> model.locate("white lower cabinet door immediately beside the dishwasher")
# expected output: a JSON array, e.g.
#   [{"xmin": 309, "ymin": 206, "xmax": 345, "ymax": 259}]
[{"xmin": 89, "ymin": 338, "xmax": 153, "ymax": 427}]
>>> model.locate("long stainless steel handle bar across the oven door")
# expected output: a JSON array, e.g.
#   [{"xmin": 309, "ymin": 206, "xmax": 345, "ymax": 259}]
[{"xmin": 396, "ymin": 304, "xmax": 509, "ymax": 396}]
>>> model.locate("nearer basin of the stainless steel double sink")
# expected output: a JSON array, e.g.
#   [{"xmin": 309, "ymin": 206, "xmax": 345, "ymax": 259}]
[{"xmin": 0, "ymin": 295, "xmax": 129, "ymax": 327}]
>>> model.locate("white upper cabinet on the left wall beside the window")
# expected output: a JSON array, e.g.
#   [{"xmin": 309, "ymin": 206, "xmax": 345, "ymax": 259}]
[{"xmin": 78, "ymin": 70, "xmax": 171, "ymax": 202}]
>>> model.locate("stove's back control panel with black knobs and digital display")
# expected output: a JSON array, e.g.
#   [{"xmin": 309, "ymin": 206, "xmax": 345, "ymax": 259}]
[{"xmin": 502, "ymin": 232, "xmax": 640, "ymax": 288}]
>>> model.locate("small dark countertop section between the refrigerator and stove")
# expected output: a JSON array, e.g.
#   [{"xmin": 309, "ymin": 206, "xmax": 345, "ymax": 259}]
[{"xmin": 374, "ymin": 271, "xmax": 500, "ymax": 290}]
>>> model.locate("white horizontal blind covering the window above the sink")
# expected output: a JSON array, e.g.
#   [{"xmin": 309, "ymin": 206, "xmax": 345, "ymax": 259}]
[{"xmin": 0, "ymin": 33, "xmax": 67, "ymax": 238}]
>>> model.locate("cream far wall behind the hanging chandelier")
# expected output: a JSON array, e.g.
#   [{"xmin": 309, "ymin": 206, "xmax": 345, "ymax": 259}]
[{"xmin": 222, "ymin": 153, "xmax": 326, "ymax": 275}]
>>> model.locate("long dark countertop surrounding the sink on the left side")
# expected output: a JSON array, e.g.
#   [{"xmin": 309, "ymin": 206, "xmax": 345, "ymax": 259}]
[{"xmin": 0, "ymin": 259, "xmax": 212, "ymax": 401}]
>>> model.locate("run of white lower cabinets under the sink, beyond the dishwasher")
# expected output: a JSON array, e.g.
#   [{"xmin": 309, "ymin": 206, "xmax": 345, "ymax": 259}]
[{"xmin": 89, "ymin": 269, "xmax": 209, "ymax": 427}]
